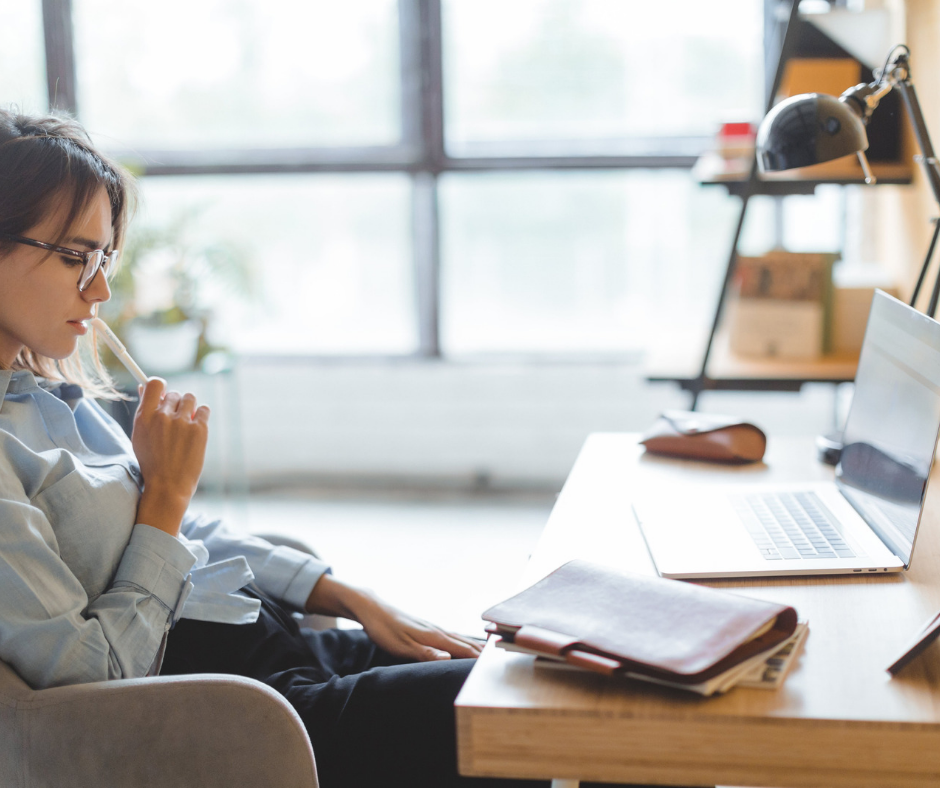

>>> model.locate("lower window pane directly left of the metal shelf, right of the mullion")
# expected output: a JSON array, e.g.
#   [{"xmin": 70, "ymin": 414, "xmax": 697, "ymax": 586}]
[{"xmin": 441, "ymin": 169, "xmax": 735, "ymax": 355}]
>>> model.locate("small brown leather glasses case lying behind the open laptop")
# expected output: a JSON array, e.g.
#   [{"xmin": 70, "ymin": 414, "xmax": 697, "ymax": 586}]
[{"xmin": 640, "ymin": 410, "xmax": 767, "ymax": 463}]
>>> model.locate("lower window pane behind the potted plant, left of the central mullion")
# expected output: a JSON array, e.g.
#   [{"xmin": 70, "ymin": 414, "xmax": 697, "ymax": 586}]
[{"xmin": 137, "ymin": 173, "xmax": 417, "ymax": 355}]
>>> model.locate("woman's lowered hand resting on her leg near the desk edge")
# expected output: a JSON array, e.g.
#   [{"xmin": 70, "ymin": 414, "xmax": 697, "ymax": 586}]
[{"xmin": 307, "ymin": 575, "xmax": 482, "ymax": 662}]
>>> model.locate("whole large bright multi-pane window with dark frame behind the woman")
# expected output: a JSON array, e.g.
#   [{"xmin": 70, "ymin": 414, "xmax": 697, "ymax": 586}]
[{"xmin": 27, "ymin": 0, "xmax": 789, "ymax": 357}]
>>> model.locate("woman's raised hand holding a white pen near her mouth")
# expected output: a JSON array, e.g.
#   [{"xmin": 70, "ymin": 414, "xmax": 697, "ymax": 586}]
[{"xmin": 131, "ymin": 378, "xmax": 209, "ymax": 536}]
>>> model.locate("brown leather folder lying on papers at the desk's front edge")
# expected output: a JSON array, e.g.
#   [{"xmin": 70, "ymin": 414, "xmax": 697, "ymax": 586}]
[{"xmin": 483, "ymin": 561, "xmax": 797, "ymax": 684}]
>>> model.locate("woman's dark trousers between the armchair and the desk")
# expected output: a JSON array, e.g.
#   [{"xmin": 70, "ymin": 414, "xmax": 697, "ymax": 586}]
[{"xmin": 161, "ymin": 594, "xmax": 696, "ymax": 788}]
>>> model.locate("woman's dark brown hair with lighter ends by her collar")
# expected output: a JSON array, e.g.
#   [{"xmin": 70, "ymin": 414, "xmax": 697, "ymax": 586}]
[{"xmin": 0, "ymin": 109, "xmax": 136, "ymax": 394}]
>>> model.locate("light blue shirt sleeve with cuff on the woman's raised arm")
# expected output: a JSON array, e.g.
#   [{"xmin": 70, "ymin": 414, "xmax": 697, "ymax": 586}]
[{"xmin": 0, "ymin": 486, "xmax": 195, "ymax": 689}]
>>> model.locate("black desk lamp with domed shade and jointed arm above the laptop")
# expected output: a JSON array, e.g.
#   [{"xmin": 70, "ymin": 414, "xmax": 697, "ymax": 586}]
[{"xmin": 757, "ymin": 44, "xmax": 940, "ymax": 317}]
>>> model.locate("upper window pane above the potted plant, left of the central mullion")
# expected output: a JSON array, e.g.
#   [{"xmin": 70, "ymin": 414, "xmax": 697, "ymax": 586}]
[{"xmin": 73, "ymin": 0, "xmax": 401, "ymax": 150}]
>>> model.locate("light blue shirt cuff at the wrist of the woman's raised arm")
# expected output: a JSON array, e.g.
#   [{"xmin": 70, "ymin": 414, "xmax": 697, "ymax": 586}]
[{"xmin": 113, "ymin": 523, "xmax": 196, "ymax": 613}]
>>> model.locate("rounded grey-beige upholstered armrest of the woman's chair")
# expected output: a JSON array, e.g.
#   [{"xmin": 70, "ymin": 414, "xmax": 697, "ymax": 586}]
[{"xmin": 11, "ymin": 674, "xmax": 317, "ymax": 788}]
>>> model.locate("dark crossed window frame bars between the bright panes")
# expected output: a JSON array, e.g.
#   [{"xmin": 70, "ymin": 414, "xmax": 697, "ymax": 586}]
[{"xmin": 42, "ymin": 0, "xmax": 752, "ymax": 361}]
